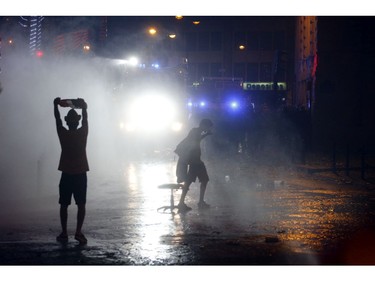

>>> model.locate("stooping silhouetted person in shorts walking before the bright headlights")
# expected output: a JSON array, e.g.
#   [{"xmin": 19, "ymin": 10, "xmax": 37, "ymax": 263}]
[{"xmin": 175, "ymin": 119, "xmax": 213, "ymax": 212}]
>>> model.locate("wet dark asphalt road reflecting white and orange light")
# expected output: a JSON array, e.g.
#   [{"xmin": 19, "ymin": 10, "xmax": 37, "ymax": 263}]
[{"xmin": 0, "ymin": 151, "xmax": 375, "ymax": 265}]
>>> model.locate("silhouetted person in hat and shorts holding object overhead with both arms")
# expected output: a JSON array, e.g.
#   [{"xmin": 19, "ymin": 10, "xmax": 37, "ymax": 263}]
[{"xmin": 54, "ymin": 98, "xmax": 89, "ymax": 244}]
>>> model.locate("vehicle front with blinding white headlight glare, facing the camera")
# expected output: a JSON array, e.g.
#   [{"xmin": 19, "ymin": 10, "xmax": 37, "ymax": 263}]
[{"xmin": 106, "ymin": 58, "xmax": 188, "ymax": 154}]
